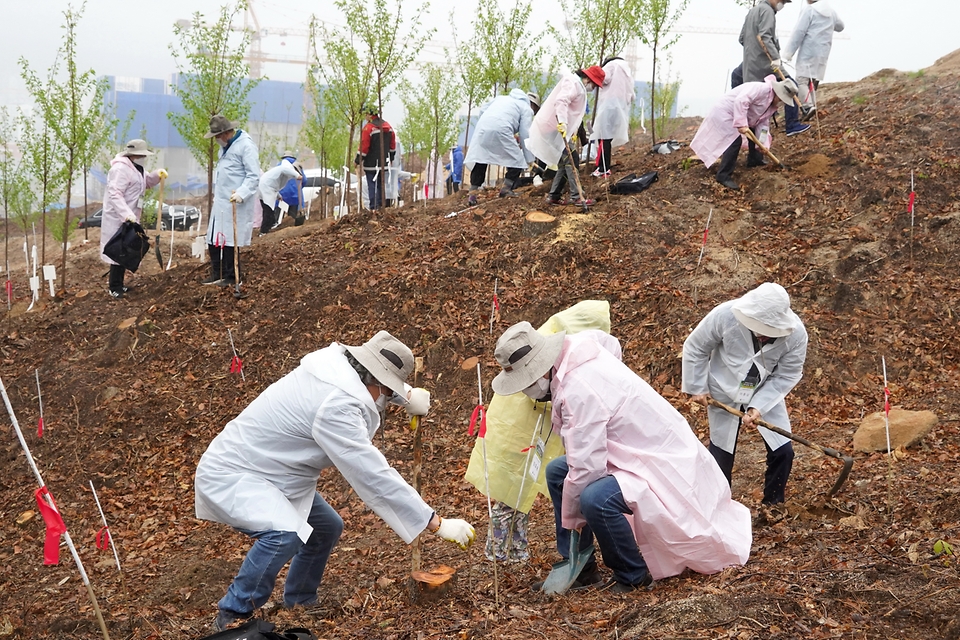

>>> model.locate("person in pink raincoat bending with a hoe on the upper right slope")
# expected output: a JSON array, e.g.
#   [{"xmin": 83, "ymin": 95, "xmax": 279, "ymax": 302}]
[{"xmin": 690, "ymin": 75, "xmax": 798, "ymax": 191}]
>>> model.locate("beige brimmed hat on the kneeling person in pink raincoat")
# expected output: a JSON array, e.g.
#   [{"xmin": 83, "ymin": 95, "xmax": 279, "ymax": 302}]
[{"xmin": 493, "ymin": 322, "xmax": 567, "ymax": 396}]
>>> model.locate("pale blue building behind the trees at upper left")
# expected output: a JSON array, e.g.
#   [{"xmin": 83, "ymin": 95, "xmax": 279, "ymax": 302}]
[{"xmin": 88, "ymin": 74, "xmax": 304, "ymax": 199}]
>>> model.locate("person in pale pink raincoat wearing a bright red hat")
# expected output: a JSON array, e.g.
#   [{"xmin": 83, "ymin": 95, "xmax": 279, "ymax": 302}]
[{"xmin": 526, "ymin": 66, "xmax": 604, "ymax": 205}]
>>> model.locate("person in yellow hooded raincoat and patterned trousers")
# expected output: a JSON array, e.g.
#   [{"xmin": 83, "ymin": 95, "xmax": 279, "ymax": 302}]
[{"xmin": 465, "ymin": 300, "xmax": 610, "ymax": 562}]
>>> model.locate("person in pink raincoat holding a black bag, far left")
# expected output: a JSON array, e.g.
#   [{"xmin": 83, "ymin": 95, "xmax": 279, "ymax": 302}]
[{"xmin": 100, "ymin": 139, "xmax": 167, "ymax": 298}]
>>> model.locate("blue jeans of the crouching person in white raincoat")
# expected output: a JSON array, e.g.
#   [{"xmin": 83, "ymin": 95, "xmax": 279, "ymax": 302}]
[{"xmin": 217, "ymin": 493, "xmax": 343, "ymax": 618}]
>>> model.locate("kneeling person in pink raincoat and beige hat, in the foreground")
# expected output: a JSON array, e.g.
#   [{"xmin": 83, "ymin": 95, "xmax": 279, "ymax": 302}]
[{"xmin": 493, "ymin": 322, "xmax": 752, "ymax": 593}]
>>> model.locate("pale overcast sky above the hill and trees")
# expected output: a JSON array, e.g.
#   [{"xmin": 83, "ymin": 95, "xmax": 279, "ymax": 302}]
[{"xmin": 0, "ymin": 0, "xmax": 960, "ymax": 122}]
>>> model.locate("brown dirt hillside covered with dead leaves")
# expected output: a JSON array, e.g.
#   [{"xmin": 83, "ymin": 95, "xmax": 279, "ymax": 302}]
[{"xmin": 0, "ymin": 54, "xmax": 960, "ymax": 640}]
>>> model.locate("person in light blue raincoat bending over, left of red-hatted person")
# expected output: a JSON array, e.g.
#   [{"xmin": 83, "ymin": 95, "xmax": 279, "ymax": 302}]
[{"xmin": 463, "ymin": 89, "xmax": 533, "ymax": 207}]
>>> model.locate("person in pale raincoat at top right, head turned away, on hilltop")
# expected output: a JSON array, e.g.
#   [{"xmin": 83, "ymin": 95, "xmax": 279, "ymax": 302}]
[{"xmin": 783, "ymin": 0, "xmax": 843, "ymax": 106}]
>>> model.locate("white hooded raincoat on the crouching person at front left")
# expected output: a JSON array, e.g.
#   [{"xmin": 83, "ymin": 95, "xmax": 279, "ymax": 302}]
[{"xmin": 195, "ymin": 343, "xmax": 433, "ymax": 544}]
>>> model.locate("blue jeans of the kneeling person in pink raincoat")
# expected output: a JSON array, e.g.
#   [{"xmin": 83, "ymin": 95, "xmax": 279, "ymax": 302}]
[{"xmin": 544, "ymin": 456, "xmax": 648, "ymax": 585}]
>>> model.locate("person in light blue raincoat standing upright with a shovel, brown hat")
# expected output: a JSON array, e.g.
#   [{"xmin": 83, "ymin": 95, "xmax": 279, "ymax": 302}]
[{"xmin": 201, "ymin": 115, "xmax": 260, "ymax": 287}]
